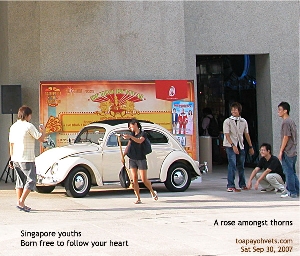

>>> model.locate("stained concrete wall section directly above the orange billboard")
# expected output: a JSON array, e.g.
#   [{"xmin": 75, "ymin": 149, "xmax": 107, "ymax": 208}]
[{"xmin": 40, "ymin": 1, "xmax": 186, "ymax": 80}]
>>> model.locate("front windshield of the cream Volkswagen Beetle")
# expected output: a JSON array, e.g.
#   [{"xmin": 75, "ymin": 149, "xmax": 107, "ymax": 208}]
[{"xmin": 74, "ymin": 127, "xmax": 105, "ymax": 145}]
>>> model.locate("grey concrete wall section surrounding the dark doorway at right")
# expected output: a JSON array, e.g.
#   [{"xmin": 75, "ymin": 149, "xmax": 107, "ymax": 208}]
[{"xmin": 184, "ymin": 1, "xmax": 299, "ymax": 154}]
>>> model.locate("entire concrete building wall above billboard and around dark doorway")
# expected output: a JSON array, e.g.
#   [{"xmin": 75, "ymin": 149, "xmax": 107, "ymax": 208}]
[{"xmin": 0, "ymin": 1, "xmax": 299, "ymax": 173}]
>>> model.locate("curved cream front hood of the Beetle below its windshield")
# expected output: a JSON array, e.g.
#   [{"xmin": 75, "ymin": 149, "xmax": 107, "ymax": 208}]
[{"xmin": 35, "ymin": 143, "xmax": 99, "ymax": 171}]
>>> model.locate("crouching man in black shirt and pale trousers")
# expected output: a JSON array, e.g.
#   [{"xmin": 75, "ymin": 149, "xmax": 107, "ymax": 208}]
[{"xmin": 247, "ymin": 143, "xmax": 286, "ymax": 193}]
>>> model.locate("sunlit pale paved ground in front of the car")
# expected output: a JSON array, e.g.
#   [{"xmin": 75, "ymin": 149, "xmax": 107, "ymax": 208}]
[{"xmin": 0, "ymin": 166, "xmax": 300, "ymax": 256}]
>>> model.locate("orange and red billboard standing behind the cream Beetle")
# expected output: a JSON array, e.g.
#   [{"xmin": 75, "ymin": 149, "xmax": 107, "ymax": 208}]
[{"xmin": 40, "ymin": 80, "xmax": 197, "ymax": 159}]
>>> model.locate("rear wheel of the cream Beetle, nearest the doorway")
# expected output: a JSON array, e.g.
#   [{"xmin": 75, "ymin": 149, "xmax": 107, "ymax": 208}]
[{"xmin": 165, "ymin": 163, "xmax": 191, "ymax": 192}]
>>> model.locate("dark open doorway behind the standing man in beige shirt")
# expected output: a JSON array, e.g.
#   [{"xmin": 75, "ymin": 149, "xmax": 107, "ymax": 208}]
[{"xmin": 196, "ymin": 55, "xmax": 258, "ymax": 167}]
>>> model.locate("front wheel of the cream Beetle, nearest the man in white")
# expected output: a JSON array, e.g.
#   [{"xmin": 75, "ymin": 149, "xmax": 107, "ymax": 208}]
[{"xmin": 65, "ymin": 167, "xmax": 91, "ymax": 197}]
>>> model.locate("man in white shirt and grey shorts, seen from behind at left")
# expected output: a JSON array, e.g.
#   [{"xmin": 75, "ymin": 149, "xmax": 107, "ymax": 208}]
[{"xmin": 9, "ymin": 106, "xmax": 45, "ymax": 212}]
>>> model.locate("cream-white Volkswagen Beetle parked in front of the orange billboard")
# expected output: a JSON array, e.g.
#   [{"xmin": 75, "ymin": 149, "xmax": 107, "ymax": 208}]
[{"xmin": 36, "ymin": 119, "xmax": 207, "ymax": 197}]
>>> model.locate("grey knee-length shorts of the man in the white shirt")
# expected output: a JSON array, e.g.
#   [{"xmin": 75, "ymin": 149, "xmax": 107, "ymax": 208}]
[{"xmin": 13, "ymin": 162, "xmax": 36, "ymax": 191}]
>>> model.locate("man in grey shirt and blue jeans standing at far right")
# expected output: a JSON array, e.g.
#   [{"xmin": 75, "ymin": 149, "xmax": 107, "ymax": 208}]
[{"xmin": 278, "ymin": 101, "xmax": 299, "ymax": 198}]
